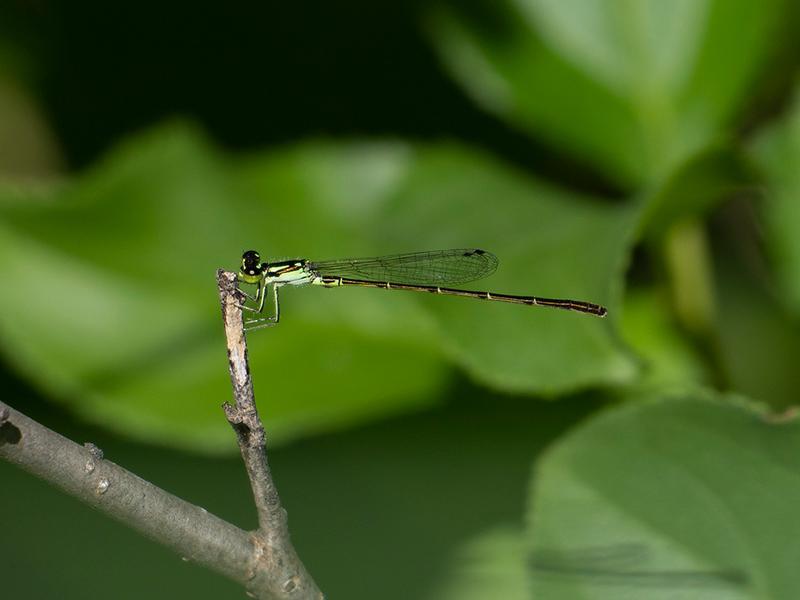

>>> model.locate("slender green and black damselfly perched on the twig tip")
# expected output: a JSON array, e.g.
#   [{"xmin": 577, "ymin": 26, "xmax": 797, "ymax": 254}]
[{"xmin": 239, "ymin": 248, "xmax": 607, "ymax": 330}]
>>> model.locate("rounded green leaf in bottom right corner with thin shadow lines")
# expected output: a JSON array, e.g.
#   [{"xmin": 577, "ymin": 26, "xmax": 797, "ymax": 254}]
[{"xmin": 529, "ymin": 393, "xmax": 800, "ymax": 599}]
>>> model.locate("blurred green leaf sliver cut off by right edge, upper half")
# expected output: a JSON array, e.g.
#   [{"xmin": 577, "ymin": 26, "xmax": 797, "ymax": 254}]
[{"xmin": 751, "ymin": 88, "xmax": 800, "ymax": 314}]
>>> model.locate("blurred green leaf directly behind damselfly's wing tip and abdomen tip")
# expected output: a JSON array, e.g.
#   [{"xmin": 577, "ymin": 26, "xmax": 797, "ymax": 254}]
[{"xmin": 366, "ymin": 147, "xmax": 638, "ymax": 394}]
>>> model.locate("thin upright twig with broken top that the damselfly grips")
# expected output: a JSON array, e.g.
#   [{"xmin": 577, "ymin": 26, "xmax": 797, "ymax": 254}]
[{"xmin": 217, "ymin": 270, "xmax": 323, "ymax": 600}]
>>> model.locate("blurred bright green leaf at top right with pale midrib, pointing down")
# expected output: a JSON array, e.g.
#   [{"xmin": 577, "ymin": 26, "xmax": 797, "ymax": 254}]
[{"xmin": 432, "ymin": 0, "xmax": 786, "ymax": 187}]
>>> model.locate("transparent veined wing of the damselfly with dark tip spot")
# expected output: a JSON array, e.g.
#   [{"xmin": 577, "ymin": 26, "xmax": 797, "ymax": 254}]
[{"xmin": 306, "ymin": 248, "xmax": 498, "ymax": 285}]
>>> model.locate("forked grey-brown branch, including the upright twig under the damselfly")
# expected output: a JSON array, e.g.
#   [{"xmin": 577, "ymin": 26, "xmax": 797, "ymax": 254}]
[{"xmin": 0, "ymin": 271, "xmax": 323, "ymax": 600}]
